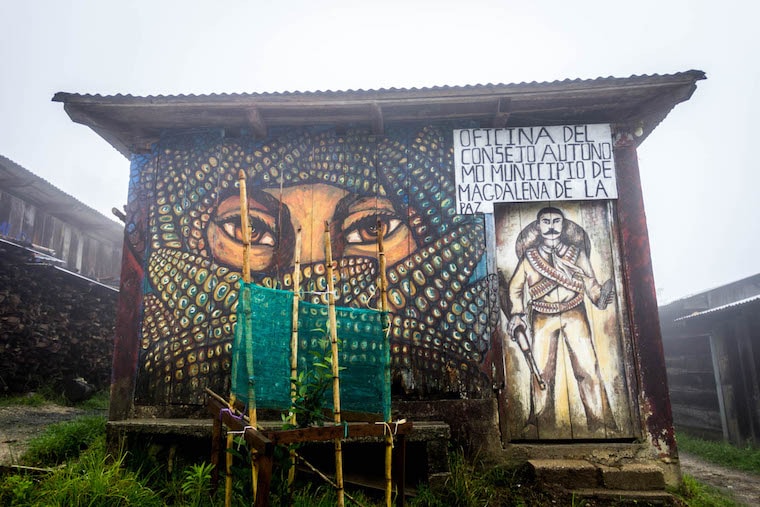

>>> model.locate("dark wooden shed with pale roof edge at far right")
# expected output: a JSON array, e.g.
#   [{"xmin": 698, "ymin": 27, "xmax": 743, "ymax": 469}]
[{"xmin": 660, "ymin": 275, "xmax": 760, "ymax": 446}]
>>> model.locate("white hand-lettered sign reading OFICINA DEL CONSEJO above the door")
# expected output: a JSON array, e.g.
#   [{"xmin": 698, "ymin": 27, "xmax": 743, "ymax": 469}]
[{"xmin": 454, "ymin": 125, "xmax": 617, "ymax": 214}]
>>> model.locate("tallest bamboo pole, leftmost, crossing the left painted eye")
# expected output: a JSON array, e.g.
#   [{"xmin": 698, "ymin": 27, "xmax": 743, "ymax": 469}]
[{"xmin": 236, "ymin": 169, "xmax": 259, "ymax": 505}]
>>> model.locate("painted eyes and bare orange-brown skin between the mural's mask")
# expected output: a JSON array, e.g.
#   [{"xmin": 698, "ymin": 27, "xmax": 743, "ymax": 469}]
[{"xmin": 207, "ymin": 183, "xmax": 417, "ymax": 273}]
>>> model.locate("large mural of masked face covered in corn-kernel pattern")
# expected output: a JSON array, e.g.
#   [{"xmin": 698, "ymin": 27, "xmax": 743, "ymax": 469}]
[{"xmin": 136, "ymin": 128, "xmax": 497, "ymax": 404}]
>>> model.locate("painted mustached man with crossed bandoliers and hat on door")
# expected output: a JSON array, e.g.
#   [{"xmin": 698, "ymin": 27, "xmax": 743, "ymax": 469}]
[{"xmin": 507, "ymin": 207, "xmax": 614, "ymax": 432}]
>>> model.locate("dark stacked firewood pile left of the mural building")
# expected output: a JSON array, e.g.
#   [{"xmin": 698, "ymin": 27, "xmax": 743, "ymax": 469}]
[{"xmin": 0, "ymin": 245, "xmax": 118, "ymax": 394}]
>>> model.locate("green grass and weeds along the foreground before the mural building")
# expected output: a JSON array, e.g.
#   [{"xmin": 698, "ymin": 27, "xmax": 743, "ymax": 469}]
[{"xmin": 0, "ymin": 417, "xmax": 550, "ymax": 507}]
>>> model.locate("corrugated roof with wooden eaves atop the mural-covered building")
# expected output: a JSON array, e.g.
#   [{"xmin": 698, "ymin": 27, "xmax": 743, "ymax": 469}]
[{"xmin": 53, "ymin": 70, "xmax": 705, "ymax": 157}]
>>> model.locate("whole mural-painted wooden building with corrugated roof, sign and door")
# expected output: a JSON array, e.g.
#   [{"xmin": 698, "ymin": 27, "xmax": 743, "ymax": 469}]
[{"xmin": 54, "ymin": 71, "xmax": 704, "ymax": 500}]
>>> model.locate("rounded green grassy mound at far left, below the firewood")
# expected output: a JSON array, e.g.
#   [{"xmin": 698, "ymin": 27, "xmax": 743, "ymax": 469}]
[{"xmin": 21, "ymin": 416, "xmax": 106, "ymax": 466}]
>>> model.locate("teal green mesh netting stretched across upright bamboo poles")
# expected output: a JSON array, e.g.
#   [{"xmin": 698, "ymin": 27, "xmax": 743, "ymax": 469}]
[{"xmin": 231, "ymin": 282, "xmax": 390, "ymax": 420}]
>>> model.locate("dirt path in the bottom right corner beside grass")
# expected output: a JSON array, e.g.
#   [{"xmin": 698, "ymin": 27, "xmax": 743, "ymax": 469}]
[{"xmin": 678, "ymin": 451, "xmax": 760, "ymax": 506}]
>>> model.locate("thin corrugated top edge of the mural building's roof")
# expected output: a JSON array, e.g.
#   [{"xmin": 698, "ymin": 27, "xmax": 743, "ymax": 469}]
[{"xmin": 52, "ymin": 70, "xmax": 706, "ymax": 106}]
